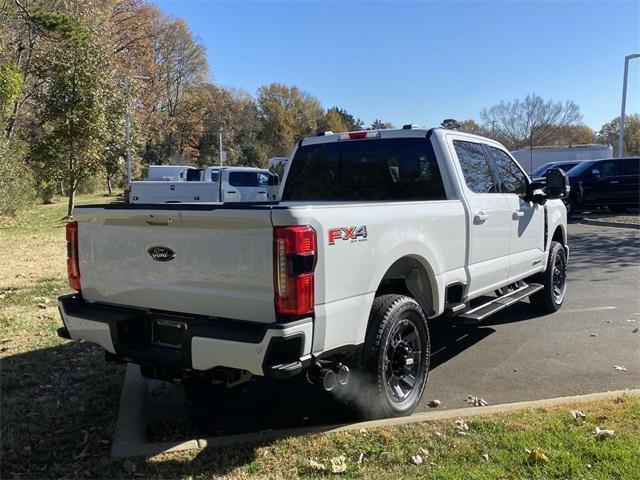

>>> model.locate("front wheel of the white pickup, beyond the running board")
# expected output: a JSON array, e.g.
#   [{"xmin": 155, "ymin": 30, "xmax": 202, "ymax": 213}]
[{"xmin": 529, "ymin": 241, "xmax": 567, "ymax": 313}]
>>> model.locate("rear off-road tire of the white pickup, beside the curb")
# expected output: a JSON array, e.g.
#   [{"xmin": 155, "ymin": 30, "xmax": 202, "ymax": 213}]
[{"xmin": 351, "ymin": 294, "xmax": 431, "ymax": 418}]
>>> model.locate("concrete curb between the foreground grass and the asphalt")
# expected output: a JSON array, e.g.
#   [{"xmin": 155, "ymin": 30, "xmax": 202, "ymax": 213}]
[{"xmin": 111, "ymin": 378, "xmax": 640, "ymax": 458}]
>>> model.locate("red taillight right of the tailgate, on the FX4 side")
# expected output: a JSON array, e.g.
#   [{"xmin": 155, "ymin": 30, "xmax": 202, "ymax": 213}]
[{"xmin": 273, "ymin": 225, "xmax": 317, "ymax": 315}]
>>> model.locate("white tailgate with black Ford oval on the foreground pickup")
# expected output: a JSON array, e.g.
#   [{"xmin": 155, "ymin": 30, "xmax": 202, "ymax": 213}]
[{"xmin": 74, "ymin": 206, "xmax": 275, "ymax": 323}]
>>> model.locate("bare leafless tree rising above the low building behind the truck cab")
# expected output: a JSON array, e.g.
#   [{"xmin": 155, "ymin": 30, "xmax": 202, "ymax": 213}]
[{"xmin": 480, "ymin": 94, "xmax": 582, "ymax": 149}]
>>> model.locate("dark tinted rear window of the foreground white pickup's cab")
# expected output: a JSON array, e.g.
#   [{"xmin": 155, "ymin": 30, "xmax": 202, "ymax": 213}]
[{"xmin": 282, "ymin": 138, "xmax": 445, "ymax": 201}]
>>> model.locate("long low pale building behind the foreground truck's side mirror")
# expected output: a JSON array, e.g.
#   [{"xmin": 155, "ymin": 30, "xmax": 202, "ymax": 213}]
[{"xmin": 511, "ymin": 143, "xmax": 613, "ymax": 173}]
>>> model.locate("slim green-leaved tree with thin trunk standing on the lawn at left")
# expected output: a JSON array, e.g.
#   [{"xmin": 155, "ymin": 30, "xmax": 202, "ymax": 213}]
[{"xmin": 32, "ymin": 39, "xmax": 120, "ymax": 216}]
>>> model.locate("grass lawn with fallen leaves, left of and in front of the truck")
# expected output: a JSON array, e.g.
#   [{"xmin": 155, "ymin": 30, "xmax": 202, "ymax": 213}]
[{"xmin": 0, "ymin": 195, "xmax": 640, "ymax": 479}]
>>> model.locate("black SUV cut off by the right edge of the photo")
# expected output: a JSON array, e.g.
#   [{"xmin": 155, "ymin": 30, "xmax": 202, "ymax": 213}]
[{"xmin": 566, "ymin": 157, "xmax": 640, "ymax": 215}]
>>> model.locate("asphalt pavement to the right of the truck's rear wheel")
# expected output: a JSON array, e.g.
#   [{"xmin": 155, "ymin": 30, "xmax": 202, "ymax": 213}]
[{"xmin": 422, "ymin": 224, "xmax": 640, "ymax": 409}]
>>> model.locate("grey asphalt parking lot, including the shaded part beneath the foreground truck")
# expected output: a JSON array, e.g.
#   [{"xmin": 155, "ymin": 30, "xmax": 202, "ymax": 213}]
[{"xmin": 132, "ymin": 223, "xmax": 640, "ymax": 440}]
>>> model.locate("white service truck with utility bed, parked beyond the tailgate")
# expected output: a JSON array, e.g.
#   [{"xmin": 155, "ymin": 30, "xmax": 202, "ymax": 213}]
[{"xmin": 128, "ymin": 167, "xmax": 278, "ymax": 205}]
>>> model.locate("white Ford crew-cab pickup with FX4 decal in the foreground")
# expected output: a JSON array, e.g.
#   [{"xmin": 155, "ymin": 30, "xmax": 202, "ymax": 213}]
[{"xmin": 59, "ymin": 126, "xmax": 569, "ymax": 416}]
